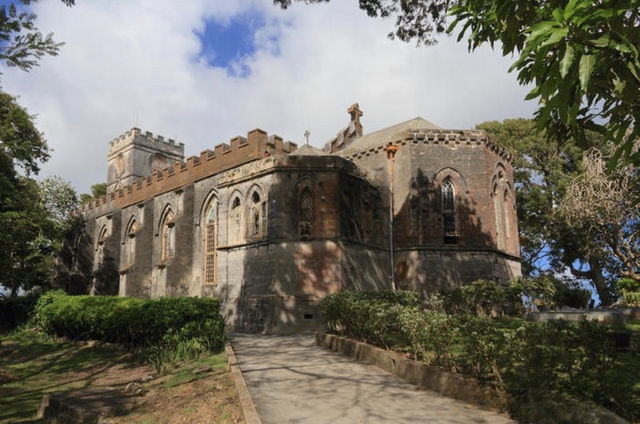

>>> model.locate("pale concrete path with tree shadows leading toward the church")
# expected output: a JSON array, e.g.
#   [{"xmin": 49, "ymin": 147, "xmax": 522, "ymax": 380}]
[{"xmin": 231, "ymin": 335, "xmax": 513, "ymax": 424}]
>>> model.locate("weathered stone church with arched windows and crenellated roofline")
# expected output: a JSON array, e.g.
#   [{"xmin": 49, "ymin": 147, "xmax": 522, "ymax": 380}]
[{"xmin": 75, "ymin": 104, "xmax": 520, "ymax": 332}]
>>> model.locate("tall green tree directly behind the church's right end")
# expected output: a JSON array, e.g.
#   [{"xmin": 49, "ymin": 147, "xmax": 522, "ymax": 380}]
[{"xmin": 477, "ymin": 119, "xmax": 613, "ymax": 304}]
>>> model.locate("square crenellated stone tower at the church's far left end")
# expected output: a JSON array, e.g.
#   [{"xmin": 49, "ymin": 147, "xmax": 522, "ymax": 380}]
[{"xmin": 107, "ymin": 127, "xmax": 184, "ymax": 193}]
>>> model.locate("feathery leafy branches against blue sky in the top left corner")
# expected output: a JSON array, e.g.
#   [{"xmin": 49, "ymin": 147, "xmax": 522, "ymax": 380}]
[{"xmin": 0, "ymin": 0, "xmax": 75, "ymax": 71}]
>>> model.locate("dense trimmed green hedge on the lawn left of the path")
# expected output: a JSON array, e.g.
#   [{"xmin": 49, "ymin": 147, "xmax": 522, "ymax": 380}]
[{"xmin": 33, "ymin": 292, "xmax": 224, "ymax": 349}]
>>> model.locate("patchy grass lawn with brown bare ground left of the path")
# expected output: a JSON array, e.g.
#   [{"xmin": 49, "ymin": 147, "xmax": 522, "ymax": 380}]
[{"xmin": 0, "ymin": 332, "xmax": 243, "ymax": 424}]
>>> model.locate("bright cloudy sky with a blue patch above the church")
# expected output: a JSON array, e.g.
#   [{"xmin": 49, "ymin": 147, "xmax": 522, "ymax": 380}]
[{"xmin": 0, "ymin": 0, "xmax": 536, "ymax": 192}]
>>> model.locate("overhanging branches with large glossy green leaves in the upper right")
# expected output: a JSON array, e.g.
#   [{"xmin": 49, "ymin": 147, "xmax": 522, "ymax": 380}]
[{"xmin": 274, "ymin": 0, "xmax": 640, "ymax": 163}]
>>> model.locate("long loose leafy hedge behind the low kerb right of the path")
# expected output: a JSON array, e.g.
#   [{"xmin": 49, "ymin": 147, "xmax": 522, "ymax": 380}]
[{"xmin": 320, "ymin": 283, "xmax": 640, "ymax": 422}]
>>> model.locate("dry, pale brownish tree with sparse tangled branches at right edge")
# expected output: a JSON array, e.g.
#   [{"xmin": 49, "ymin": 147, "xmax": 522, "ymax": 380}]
[{"xmin": 560, "ymin": 148, "xmax": 640, "ymax": 282}]
